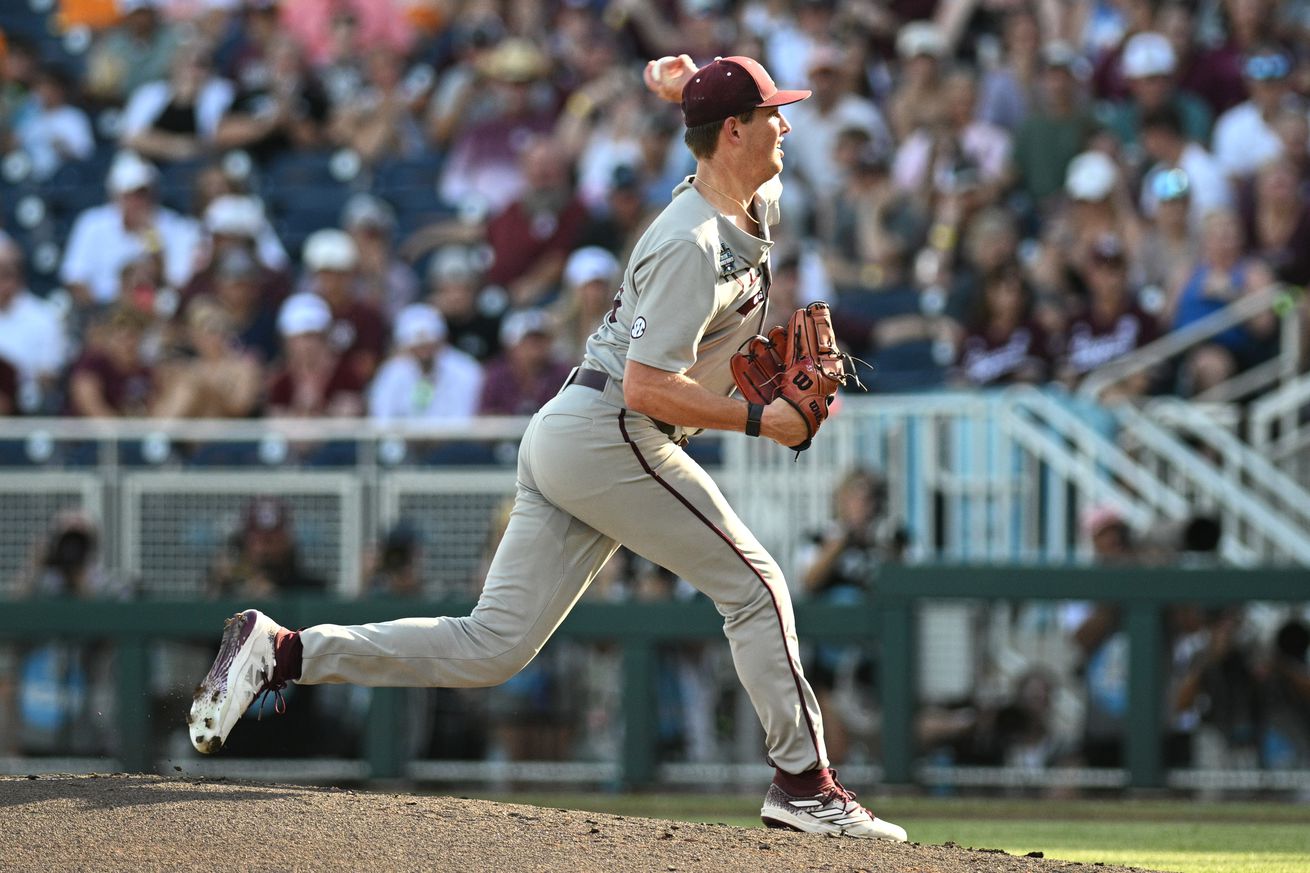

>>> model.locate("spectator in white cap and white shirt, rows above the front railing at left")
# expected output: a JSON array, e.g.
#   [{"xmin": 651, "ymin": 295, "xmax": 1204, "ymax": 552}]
[{"xmin": 59, "ymin": 152, "xmax": 199, "ymax": 305}]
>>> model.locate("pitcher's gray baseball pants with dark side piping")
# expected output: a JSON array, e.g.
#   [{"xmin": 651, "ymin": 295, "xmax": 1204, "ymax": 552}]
[{"xmin": 299, "ymin": 383, "xmax": 828, "ymax": 773}]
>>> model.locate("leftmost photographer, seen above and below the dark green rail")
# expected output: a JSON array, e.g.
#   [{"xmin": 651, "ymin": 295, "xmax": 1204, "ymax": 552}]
[{"xmin": 0, "ymin": 511, "xmax": 130, "ymax": 755}]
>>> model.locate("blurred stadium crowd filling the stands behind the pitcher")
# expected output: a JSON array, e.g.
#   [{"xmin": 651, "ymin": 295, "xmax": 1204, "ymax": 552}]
[{"xmin": 0, "ymin": 0, "xmax": 1310, "ymax": 419}]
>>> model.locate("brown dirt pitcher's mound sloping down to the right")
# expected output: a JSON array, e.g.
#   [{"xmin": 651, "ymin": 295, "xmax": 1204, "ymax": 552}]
[{"xmin": 0, "ymin": 775, "xmax": 1168, "ymax": 873}]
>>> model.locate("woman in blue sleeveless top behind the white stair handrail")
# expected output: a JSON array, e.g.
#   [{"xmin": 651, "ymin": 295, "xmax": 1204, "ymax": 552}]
[{"xmin": 1166, "ymin": 210, "xmax": 1277, "ymax": 396}]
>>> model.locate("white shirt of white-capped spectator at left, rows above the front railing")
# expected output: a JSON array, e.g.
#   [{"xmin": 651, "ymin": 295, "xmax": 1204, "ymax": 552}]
[{"xmin": 59, "ymin": 203, "xmax": 200, "ymax": 303}]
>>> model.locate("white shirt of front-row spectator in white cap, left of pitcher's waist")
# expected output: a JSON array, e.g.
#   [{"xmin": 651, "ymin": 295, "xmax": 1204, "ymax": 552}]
[{"xmin": 368, "ymin": 346, "xmax": 482, "ymax": 422}]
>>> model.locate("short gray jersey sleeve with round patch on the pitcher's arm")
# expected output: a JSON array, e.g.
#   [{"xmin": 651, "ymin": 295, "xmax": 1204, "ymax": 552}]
[{"xmin": 627, "ymin": 240, "xmax": 715, "ymax": 374}]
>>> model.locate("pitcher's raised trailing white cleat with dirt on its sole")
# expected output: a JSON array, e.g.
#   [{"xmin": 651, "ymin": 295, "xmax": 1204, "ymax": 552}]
[{"xmin": 186, "ymin": 610, "xmax": 286, "ymax": 755}]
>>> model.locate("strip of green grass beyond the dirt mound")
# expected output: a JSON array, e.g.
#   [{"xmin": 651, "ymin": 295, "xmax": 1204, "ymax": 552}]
[{"xmin": 495, "ymin": 794, "xmax": 1310, "ymax": 873}]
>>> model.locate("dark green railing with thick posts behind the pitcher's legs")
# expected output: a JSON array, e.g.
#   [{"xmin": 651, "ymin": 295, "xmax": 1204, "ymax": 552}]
[{"xmin": 0, "ymin": 566, "xmax": 1307, "ymax": 788}]
